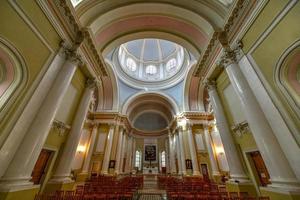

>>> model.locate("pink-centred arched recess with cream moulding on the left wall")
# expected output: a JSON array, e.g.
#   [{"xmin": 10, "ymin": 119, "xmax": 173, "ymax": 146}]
[{"xmin": 0, "ymin": 37, "xmax": 28, "ymax": 119}]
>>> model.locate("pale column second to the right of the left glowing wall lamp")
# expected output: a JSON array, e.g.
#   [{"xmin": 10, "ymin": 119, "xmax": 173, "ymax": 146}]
[{"xmin": 101, "ymin": 124, "xmax": 115, "ymax": 174}]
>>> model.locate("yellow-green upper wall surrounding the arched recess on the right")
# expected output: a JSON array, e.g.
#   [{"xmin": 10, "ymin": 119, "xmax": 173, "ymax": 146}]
[{"xmin": 242, "ymin": 0, "xmax": 300, "ymax": 134}]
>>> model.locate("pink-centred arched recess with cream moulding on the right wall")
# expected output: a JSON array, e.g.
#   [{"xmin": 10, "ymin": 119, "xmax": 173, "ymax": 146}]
[{"xmin": 274, "ymin": 40, "xmax": 300, "ymax": 119}]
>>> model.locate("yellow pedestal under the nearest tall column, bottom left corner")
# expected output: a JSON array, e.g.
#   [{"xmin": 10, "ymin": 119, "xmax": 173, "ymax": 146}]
[{"xmin": 0, "ymin": 185, "xmax": 40, "ymax": 200}]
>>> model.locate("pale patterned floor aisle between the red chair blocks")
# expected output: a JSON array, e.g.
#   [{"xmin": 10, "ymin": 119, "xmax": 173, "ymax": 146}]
[{"xmin": 138, "ymin": 175, "xmax": 167, "ymax": 200}]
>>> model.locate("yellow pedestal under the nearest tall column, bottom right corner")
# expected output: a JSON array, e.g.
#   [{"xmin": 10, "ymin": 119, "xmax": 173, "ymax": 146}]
[{"xmin": 259, "ymin": 186, "xmax": 300, "ymax": 200}]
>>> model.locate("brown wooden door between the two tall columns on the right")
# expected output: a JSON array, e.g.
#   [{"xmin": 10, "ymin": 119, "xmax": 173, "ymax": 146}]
[{"xmin": 249, "ymin": 151, "xmax": 270, "ymax": 186}]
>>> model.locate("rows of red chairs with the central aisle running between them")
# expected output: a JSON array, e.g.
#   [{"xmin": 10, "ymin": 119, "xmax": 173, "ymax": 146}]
[{"xmin": 35, "ymin": 175, "xmax": 270, "ymax": 200}]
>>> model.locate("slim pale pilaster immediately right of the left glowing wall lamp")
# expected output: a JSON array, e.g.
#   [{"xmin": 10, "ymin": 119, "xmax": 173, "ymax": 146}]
[{"xmin": 81, "ymin": 123, "xmax": 98, "ymax": 174}]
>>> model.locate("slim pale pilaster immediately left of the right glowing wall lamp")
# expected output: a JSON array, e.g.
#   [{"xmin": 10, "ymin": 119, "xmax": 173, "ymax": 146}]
[{"xmin": 204, "ymin": 126, "xmax": 220, "ymax": 176}]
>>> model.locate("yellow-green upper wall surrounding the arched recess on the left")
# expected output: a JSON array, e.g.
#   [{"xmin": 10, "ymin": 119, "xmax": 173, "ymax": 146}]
[{"xmin": 0, "ymin": 0, "xmax": 60, "ymax": 142}]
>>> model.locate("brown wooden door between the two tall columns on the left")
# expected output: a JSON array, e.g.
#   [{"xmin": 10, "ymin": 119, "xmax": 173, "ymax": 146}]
[{"xmin": 31, "ymin": 149, "xmax": 54, "ymax": 185}]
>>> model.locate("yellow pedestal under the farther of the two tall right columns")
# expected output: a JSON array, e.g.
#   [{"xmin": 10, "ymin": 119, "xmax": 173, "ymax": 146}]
[{"xmin": 226, "ymin": 181, "xmax": 257, "ymax": 196}]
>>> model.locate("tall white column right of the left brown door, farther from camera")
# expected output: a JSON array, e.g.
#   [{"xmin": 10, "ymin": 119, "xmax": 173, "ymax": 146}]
[{"xmin": 51, "ymin": 80, "xmax": 95, "ymax": 182}]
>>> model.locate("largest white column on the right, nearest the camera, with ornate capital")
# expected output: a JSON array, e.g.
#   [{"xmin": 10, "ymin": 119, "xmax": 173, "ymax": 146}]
[{"xmin": 223, "ymin": 51, "xmax": 300, "ymax": 189}]
